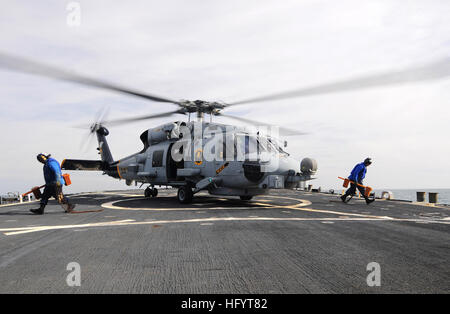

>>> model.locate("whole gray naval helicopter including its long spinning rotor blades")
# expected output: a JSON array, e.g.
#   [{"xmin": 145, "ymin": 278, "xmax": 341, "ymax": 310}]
[{"xmin": 0, "ymin": 53, "xmax": 450, "ymax": 204}]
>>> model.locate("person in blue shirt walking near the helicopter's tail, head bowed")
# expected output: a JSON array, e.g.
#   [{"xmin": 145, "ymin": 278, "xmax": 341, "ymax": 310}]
[{"xmin": 30, "ymin": 154, "xmax": 75, "ymax": 215}]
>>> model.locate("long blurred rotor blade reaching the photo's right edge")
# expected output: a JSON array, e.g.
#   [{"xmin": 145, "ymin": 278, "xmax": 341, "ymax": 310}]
[{"xmin": 227, "ymin": 58, "xmax": 450, "ymax": 107}]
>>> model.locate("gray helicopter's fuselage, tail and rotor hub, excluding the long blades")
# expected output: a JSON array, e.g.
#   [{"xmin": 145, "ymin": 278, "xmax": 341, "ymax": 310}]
[{"xmin": 61, "ymin": 101, "xmax": 317, "ymax": 204}]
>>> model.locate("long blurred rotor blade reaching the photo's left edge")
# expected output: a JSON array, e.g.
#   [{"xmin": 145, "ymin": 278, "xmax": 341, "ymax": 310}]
[{"xmin": 0, "ymin": 52, "xmax": 178, "ymax": 104}]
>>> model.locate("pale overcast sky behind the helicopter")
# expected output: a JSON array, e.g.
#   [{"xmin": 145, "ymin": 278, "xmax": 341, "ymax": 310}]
[{"xmin": 0, "ymin": 0, "xmax": 450, "ymax": 194}]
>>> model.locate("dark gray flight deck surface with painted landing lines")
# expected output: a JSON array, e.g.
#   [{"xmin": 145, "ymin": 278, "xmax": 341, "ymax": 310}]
[{"xmin": 0, "ymin": 190, "xmax": 450, "ymax": 293}]
